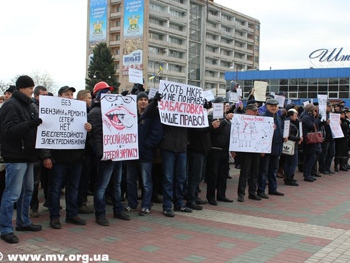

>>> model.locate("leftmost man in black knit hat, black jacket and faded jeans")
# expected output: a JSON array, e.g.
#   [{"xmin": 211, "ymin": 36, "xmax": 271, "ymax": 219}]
[{"xmin": 0, "ymin": 75, "xmax": 42, "ymax": 244}]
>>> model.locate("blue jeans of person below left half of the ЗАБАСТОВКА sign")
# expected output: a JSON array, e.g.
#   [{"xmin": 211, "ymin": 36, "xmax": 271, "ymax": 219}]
[{"xmin": 161, "ymin": 149, "xmax": 187, "ymax": 211}]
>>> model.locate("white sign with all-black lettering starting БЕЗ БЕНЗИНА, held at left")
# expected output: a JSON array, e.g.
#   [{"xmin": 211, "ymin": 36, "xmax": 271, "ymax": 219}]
[{"xmin": 35, "ymin": 96, "xmax": 87, "ymax": 150}]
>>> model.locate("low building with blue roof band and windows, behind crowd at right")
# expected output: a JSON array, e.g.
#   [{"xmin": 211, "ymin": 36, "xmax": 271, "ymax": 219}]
[{"xmin": 225, "ymin": 68, "xmax": 350, "ymax": 100}]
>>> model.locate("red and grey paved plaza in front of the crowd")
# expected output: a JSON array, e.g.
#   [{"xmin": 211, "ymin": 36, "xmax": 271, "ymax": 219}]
[{"xmin": 0, "ymin": 168, "xmax": 350, "ymax": 263}]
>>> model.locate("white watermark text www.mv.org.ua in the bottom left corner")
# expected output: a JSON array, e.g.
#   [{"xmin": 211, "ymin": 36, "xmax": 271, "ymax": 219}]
[{"xmin": 0, "ymin": 252, "xmax": 109, "ymax": 263}]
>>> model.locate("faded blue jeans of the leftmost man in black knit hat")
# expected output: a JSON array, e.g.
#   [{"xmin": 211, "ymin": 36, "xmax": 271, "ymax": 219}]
[{"xmin": 0, "ymin": 163, "xmax": 34, "ymax": 235}]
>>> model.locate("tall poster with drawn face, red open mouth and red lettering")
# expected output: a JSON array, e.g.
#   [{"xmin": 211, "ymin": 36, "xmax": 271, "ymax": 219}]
[{"xmin": 101, "ymin": 94, "xmax": 139, "ymax": 161}]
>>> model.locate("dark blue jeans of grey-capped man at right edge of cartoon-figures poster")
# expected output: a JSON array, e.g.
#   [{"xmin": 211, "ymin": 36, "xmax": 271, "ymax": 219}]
[{"xmin": 258, "ymin": 154, "xmax": 279, "ymax": 193}]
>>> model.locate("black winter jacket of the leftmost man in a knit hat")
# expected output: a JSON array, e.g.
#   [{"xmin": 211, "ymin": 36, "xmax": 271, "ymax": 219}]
[{"xmin": 0, "ymin": 91, "xmax": 39, "ymax": 163}]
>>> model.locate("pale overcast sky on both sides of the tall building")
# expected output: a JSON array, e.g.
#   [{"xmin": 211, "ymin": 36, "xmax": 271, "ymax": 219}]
[{"xmin": 0, "ymin": 0, "xmax": 350, "ymax": 90}]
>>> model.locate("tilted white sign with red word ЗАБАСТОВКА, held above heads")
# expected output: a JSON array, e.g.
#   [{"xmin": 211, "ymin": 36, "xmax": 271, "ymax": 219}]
[{"xmin": 158, "ymin": 80, "xmax": 209, "ymax": 128}]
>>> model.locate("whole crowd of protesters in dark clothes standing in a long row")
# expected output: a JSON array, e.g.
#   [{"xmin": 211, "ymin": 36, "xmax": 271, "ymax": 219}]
[{"xmin": 0, "ymin": 75, "xmax": 350, "ymax": 243}]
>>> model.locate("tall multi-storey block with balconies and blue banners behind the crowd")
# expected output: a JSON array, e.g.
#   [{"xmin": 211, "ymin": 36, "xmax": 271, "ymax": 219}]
[{"xmin": 87, "ymin": 0, "xmax": 260, "ymax": 94}]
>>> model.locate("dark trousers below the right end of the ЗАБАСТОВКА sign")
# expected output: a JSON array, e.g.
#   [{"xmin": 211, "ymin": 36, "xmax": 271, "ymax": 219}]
[{"xmin": 186, "ymin": 152, "xmax": 207, "ymax": 203}]
